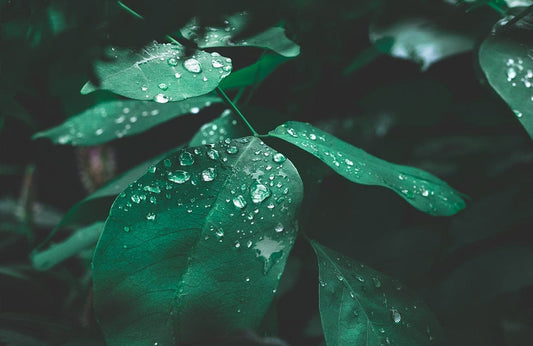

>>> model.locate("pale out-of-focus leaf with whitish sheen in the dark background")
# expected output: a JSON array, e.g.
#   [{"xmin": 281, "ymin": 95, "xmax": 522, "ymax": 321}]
[{"xmin": 369, "ymin": 13, "xmax": 475, "ymax": 70}]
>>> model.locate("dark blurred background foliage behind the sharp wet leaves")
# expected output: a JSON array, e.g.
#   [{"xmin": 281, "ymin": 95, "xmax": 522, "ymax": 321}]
[{"xmin": 0, "ymin": 0, "xmax": 533, "ymax": 345}]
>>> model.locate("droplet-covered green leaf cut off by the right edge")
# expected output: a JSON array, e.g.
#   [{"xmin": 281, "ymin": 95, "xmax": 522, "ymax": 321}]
[{"xmin": 478, "ymin": 13, "xmax": 533, "ymax": 139}]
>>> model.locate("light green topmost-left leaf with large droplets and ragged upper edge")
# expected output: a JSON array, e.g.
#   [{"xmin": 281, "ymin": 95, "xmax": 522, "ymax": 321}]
[{"xmin": 81, "ymin": 42, "xmax": 232, "ymax": 103}]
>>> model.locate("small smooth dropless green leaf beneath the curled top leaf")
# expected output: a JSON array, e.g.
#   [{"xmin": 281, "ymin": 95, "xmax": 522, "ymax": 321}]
[{"xmin": 220, "ymin": 53, "xmax": 289, "ymax": 89}]
